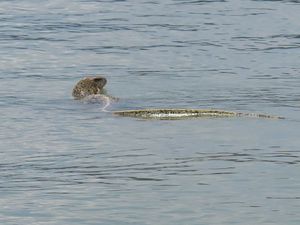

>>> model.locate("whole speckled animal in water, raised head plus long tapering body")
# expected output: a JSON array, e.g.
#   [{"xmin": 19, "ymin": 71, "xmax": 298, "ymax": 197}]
[{"xmin": 72, "ymin": 76, "xmax": 284, "ymax": 120}]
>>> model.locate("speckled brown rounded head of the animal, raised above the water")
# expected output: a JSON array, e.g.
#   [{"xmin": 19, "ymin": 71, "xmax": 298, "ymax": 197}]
[{"xmin": 72, "ymin": 76, "xmax": 107, "ymax": 99}]
